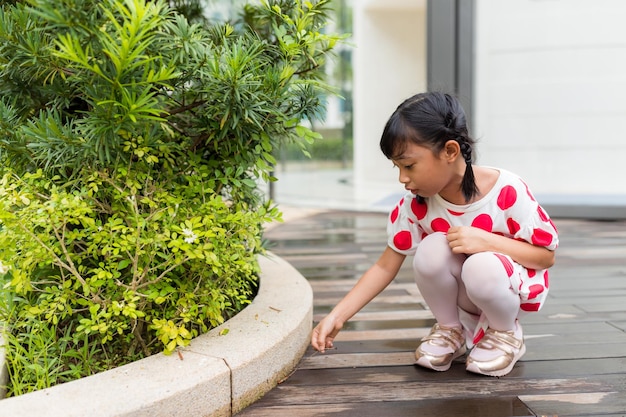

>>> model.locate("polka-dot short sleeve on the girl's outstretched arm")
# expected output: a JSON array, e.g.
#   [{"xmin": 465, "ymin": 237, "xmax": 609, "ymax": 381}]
[{"xmin": 387, "ymin": 196, "xmax": 421, "ymax": 255}]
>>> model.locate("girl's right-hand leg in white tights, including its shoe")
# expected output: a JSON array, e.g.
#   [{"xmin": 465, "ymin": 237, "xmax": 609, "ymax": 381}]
[{"xmin": 461, "ymin": 252, "xmax": 526, "ymax": 376}]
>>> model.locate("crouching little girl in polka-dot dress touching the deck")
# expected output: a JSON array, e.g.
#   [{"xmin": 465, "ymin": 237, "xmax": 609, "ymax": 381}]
[{"xmin": 311, "ymin": 93, "xmax": 558, "ymax": 376}]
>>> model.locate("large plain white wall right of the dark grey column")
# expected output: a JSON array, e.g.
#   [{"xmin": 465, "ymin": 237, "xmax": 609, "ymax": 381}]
[{"xmin": 473, "ymin": 0, "xmax": 626, "ymax": 200}]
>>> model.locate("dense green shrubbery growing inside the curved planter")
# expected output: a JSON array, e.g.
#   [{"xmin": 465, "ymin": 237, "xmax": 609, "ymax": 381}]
[{"xmin": 0, "ymin": 0, "xmax": 339, "ymax": 395}]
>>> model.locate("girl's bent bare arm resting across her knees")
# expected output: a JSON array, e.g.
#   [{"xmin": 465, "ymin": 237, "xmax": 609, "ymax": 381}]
[{"xmin": 448, "ymin": 226, "xmax": 554, "ymax": 269}]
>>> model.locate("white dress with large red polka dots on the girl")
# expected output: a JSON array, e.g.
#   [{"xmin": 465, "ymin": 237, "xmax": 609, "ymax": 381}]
[{"xmin": 387, "ymin": 169, "xmax": 558, "ymax": 311}]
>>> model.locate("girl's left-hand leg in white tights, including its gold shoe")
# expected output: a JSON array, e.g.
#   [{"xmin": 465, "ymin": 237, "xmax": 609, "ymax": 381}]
[{"xmin": 413, "ymin": 233, "xmax": 465, "ymax": 371}]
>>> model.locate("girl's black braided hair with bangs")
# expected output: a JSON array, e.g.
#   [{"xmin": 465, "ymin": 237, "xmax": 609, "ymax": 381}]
[{"xmin": 380, "ymin": 92, "xmax": 479, "ymax": 202}]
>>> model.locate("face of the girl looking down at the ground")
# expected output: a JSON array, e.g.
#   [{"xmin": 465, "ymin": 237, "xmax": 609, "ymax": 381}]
[{"xmin": 391, "ymin": 141, "xmax": 463, "ymax": 199}]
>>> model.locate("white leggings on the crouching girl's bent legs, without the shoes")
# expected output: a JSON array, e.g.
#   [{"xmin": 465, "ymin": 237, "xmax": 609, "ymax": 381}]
[{"xmin": 413, "ymin": 232, "xmax": 520, "ymax": 331}]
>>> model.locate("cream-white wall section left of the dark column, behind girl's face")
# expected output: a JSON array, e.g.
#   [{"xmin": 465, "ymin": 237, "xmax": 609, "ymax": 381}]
[{"xmin": 353, "ymin": 0, "xmax": 426, "ymax": 200}]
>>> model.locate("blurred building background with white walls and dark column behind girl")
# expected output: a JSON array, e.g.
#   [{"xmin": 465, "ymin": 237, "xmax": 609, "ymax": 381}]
[{"xmin": 203, "ymin": 0, "xmax": 626, "ymax": 218}]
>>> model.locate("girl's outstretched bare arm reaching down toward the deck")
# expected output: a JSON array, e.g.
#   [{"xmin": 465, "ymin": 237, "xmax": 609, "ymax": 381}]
[{"xmin": 311, "ymin": 247, "xmax": 406, "ymax": 353}]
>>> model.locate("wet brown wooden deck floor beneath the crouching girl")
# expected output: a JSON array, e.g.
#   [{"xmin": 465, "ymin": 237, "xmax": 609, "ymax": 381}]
[{"xmin": 239, "ymin": 211, "xmax": 626, "ymax": 417}]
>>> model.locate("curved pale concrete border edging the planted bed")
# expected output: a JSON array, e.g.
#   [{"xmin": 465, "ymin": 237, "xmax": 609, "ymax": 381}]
[{"xmin": 0, "ymin": 253, "xmax": 313, "ymax": 417}]
